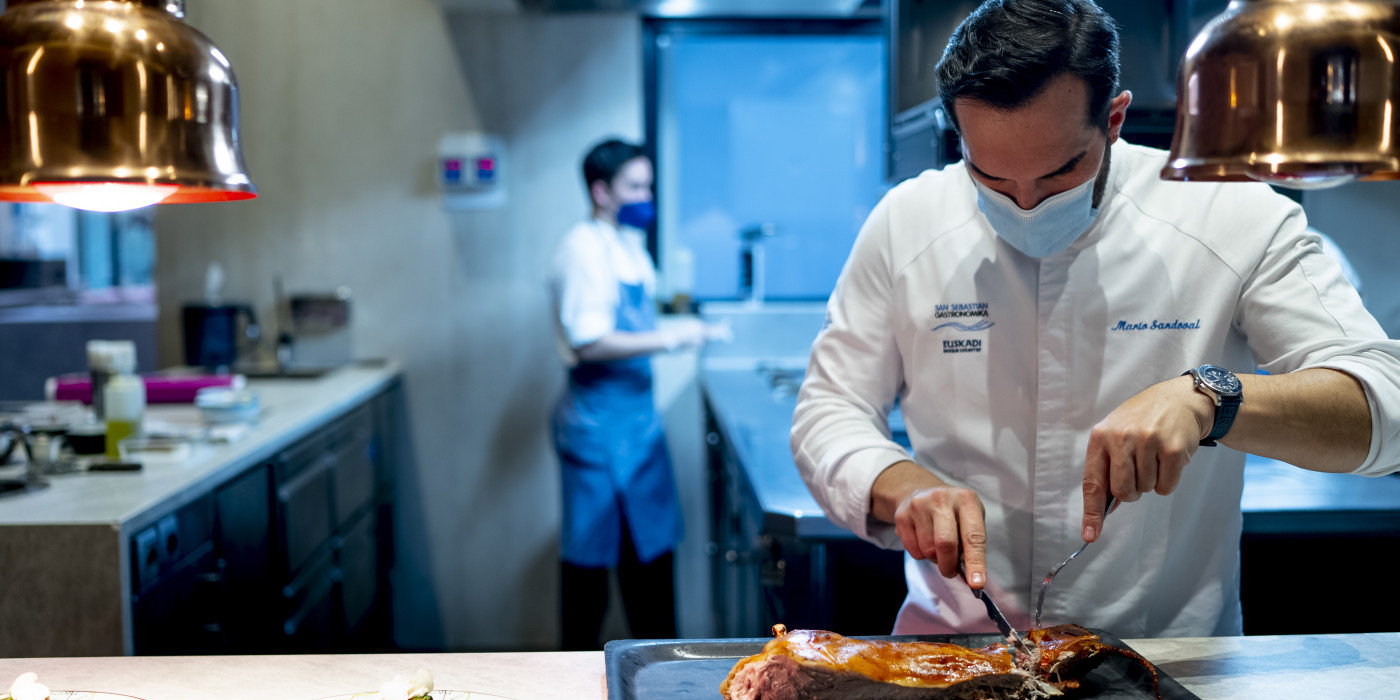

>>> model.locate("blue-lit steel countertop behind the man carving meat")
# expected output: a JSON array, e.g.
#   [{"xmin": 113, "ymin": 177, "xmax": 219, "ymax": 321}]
[{"xmin": 701, "ymin": 358, "xmax": 1400, "ymax": 539}]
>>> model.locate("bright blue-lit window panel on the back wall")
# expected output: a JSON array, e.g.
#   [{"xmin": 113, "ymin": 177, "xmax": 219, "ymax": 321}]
[{"xmin": 657, "ymin": 34, "xmax": 886, "ymax": 300}]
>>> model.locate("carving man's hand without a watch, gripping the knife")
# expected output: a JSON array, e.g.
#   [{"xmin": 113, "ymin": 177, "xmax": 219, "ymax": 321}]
[{"xmin": 871, "ymin": 461, "xmax": 987, "ymax": 588}]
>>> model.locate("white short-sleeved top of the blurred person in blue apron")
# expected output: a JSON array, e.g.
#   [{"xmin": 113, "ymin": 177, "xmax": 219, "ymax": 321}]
[{"xmin": 550, "ymin": 218, "xmax": 657, "ymax": 367}]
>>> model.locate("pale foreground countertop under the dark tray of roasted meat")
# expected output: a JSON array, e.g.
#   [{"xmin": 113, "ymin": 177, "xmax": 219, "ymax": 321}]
[{"xmin": 0, "ymin": 633, "xmax": 1400, "ymax": 700}]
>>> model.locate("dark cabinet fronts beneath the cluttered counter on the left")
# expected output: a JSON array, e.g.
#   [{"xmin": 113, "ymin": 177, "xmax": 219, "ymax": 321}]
[{"xmin": 130, "ymin": 396, "xmax": 392, "ymax": 655}]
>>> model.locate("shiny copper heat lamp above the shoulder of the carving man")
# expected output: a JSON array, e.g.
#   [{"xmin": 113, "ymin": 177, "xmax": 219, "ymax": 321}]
[{"xmin": 1162, "ymin": 0, "xmax": 1400, "ymax": 189}]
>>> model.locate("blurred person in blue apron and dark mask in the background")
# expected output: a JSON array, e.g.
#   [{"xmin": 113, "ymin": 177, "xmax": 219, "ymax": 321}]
[{"xmin": 550, "ymin": 139, "xmax": 727, "ymax": 650}]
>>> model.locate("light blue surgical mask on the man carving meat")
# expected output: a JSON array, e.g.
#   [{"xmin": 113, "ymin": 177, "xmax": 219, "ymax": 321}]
[{"xmin": 967, "ymin": 174, "xmax": 1099, "ymax": 258}]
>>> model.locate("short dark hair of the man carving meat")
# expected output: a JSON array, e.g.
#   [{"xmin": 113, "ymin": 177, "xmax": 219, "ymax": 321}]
[{"xmin": 937, "ymin": 0, "xmax": 1119, "ymax": 130}]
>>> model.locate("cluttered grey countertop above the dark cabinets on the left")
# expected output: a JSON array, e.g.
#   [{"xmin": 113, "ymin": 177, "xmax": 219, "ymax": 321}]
[{"xmin": 0, "ymin": 361, "xmax": 400, "ymax": 529}]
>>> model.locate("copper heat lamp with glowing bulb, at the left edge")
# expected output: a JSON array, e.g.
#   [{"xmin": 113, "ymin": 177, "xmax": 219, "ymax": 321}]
[{"xmin": 0, "ymin": 0, "xmax": 258, "ymax": 211}]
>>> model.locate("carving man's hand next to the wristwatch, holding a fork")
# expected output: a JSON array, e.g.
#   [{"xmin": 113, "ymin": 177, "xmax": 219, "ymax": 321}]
[{"xmin": 1084, "ymin": 377, "xmax": 1215, "ymax": 542}]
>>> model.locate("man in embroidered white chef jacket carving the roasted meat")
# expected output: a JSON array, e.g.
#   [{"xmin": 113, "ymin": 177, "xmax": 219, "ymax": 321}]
[{"xmin": 792, "ymin": 0, "xmax": 1400, "ymax": 637}]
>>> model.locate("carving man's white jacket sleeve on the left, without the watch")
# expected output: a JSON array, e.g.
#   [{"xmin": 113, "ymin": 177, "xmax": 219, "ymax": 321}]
[{"xmin": 791, "ymin": 196, "xmax": 910, "ymax": 549}]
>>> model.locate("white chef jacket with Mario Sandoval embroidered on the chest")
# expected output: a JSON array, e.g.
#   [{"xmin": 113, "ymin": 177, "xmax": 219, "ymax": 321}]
[{"xmin": 791, "ymin": 140, "xmax": 1400, "ymax": 637}]
